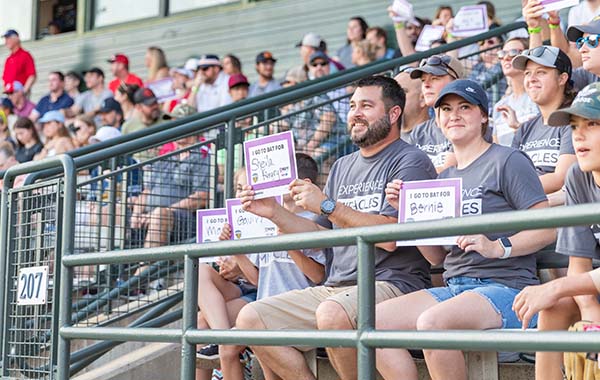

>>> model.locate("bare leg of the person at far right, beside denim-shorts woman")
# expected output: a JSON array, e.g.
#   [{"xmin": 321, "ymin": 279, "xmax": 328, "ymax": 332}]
[{"xmin": 535, "ymin": 297, "xmax": 581, "ymax": 380}]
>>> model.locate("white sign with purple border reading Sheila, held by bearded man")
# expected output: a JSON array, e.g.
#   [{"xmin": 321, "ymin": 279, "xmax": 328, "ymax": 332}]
[{"xmin": 244, "ymin": 131, "xmax": 297, "ymax": 199}]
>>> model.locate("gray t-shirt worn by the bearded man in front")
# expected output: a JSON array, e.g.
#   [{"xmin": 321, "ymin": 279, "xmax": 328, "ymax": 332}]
[{"xmin": 319, "ymin": 140, "xmax": 436, "ymax": 293}]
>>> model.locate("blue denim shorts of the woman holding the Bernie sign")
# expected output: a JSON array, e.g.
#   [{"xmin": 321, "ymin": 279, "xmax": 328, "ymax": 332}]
[{"xmin": 426, "ymin": 276, "xmax": 538, "ymax": 329}]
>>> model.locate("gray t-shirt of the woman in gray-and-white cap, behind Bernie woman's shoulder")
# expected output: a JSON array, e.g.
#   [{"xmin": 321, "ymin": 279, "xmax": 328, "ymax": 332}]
[{"xmin": 512, "ymin": 114, "xmax": 575, "ymax": 175}]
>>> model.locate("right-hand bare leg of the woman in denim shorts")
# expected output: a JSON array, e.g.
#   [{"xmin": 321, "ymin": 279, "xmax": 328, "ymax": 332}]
[{"xmin": 417, "ymin": 292, "xmax": 502, "ymax": 380}]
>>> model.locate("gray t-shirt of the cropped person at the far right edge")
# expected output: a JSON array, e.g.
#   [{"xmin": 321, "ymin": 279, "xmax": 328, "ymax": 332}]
[{"xmin": 556, "ymin": 164, "xmax": 600, "ymax": 259}]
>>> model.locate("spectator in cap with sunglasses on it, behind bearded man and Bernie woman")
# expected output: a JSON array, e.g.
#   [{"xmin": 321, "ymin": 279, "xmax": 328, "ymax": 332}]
[{"xmin": 406, "ymin": 55, "xmax": 464, "ymax": 173}]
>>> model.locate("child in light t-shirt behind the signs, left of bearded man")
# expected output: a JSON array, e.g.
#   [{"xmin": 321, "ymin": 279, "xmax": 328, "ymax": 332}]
[{"xmin": 198, "ymin": 153, "xmax": 325, "ymax": 379}]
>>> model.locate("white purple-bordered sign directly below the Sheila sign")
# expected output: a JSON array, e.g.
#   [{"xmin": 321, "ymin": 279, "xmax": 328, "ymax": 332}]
[{"xmin": 225, "ymin": 196, "xmax": 281, "ymax": 240}]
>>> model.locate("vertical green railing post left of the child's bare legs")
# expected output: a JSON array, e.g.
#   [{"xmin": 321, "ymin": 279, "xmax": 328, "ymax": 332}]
[{"xmin": 181, "ymin": 256, "xmax": 198, "ymax": 380}]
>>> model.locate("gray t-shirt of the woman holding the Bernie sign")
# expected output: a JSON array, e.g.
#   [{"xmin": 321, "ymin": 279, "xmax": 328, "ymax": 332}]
[{"xmin": 439, "ymin": 144, "xmax": 546, "ymax": 289}]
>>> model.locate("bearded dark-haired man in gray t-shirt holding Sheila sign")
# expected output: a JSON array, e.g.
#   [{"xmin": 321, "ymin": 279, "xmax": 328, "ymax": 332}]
[{"xmin": 236, "ymin": 76, "xmax": 436, "ymax": 380}]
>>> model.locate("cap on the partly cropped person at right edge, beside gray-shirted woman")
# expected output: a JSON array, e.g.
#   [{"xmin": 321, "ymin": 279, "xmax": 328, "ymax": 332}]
[{"xmin": 548, "ymin": 82, "xmax": 600, "ymax": 127}]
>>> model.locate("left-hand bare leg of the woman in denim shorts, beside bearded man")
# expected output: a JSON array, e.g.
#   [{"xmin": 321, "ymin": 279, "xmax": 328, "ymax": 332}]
[{"xmin": 375, "ymin": 290, "xmax": 438, "ymax": 380}]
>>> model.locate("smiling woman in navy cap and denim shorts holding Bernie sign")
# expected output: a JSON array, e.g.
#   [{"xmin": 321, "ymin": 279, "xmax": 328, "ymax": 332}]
[{"xmin": 376, "ymin": 80, "xmax": 555, "ymax": 379}]
